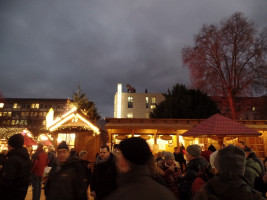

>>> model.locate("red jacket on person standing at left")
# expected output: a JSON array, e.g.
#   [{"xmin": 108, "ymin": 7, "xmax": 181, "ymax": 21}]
[{"xmin": 31, "ymin": 151, "xmax": 48, "ymax": 177}]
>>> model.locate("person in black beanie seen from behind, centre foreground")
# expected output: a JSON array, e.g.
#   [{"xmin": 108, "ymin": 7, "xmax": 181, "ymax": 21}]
[{"xmin": 107, "ymin": 137, "xmax": 177, "ymax": 200}]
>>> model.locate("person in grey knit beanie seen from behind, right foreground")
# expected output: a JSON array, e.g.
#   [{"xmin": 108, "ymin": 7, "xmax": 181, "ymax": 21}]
[{"xmin": 194, "ymin": 145, "xmax": 265, "ymax": 200}]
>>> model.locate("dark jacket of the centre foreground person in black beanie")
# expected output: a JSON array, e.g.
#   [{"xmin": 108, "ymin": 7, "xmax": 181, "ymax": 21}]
[{"xmin": 107, "ymin": 167, "xmax": 177, "ymax": 200}]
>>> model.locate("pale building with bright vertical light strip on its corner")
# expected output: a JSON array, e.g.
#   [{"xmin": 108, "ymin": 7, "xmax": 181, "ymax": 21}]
[{"xmin": 114, "ymin": 83, "xmax": 164, "ymax": 118}]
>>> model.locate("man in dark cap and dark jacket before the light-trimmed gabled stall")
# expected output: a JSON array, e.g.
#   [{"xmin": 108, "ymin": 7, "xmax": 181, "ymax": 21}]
[{"xmin": 45, "ymin": 141, "xmax": 87, "ymax": 200}]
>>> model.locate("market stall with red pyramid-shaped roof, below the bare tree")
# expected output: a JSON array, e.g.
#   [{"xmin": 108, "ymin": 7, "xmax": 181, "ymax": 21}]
[{"xmin": 182, "ymin": 114, "xmax": 265, "ymax": 158}]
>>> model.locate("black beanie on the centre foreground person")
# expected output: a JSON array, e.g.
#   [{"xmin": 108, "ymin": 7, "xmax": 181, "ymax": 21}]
[{"xmin": 119, "ymin": 137, "xmax": 152, "ymax": 165}]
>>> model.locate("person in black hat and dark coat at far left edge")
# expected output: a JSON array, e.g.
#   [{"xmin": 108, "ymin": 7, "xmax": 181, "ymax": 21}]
[{"xmin": 0, "ymin": 133, "xmax": 31, "ymax": 200}]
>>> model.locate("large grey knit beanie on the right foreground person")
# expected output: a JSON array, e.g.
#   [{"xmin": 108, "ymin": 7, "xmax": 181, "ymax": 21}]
[{"xmin": 214, "ymin": 145, "xmax": 246, "ymax": 176}]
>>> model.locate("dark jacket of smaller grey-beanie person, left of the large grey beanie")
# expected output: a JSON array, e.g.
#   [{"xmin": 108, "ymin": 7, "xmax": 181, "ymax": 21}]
[{"xmin": 178, "ymin": 157, "xmax": 209, "ymax": 200}]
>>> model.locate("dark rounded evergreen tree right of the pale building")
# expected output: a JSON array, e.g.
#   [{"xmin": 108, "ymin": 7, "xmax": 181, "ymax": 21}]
[{"xmin": 150, "ymin": 84, "xmax": 219, "ymax": 119}]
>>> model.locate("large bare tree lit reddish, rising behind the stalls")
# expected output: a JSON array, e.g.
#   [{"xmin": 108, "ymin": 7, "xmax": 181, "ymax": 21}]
[{"xmin": 182, "ymin": 12, "xmax": 267, "ymax": 119}]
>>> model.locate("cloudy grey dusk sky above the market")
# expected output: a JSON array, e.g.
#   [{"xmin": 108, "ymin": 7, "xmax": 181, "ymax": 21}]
[{"xmin": 0, "ymin": 0, "xmax": 267, "ymax": 117}]
